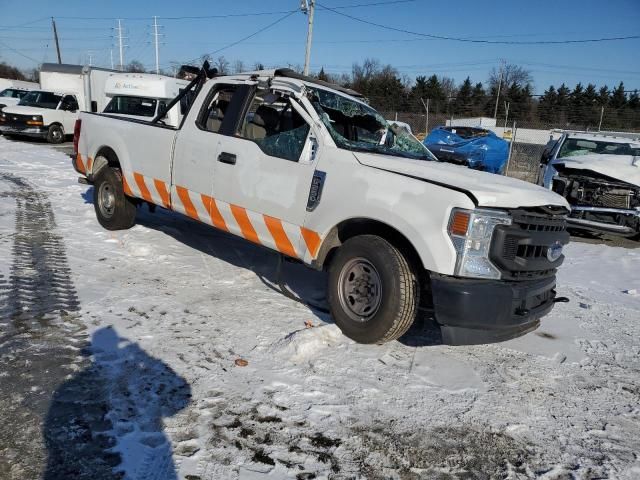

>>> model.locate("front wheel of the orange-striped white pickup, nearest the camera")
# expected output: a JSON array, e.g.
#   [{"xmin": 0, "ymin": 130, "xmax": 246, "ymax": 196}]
[{"xmin": 327, "ymin": 235, "xmax": 420, "ymax": 344}]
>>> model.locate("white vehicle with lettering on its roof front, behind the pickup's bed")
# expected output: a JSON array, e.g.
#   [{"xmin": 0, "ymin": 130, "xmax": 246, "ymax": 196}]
[{"xmin": 103, "ymin": 73, "xmax": 189, "ymax": 127}]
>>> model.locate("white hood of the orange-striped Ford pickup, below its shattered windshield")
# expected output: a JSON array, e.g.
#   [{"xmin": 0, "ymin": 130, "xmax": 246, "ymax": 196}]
[{"xmin": 354, "ymin": 152, "xmax": 569, "ymax": 208}]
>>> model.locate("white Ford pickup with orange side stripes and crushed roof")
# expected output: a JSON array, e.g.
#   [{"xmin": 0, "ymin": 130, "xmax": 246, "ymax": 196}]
[{"xmin": 72, "ymin": 68, "xmax": 569, "ymax": 344}]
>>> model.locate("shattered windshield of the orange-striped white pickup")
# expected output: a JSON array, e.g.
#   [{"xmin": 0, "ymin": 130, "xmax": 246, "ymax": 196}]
[{"xmin": 307, "ymin": 87, "xmax": 436, "ymax": 160}]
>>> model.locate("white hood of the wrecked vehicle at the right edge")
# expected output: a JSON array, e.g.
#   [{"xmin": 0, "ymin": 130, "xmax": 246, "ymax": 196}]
[{"xmin": 552, "ymin": 154, "xmax": 640, "ymax": 187}]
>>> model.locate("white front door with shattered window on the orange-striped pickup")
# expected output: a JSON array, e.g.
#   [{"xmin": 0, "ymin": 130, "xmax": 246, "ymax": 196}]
[{"xmin": 214, "ymin": 88, "xmax": 317, "ymax": 258}]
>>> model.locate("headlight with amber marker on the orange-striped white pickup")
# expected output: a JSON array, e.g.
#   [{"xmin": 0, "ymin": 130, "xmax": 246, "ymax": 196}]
[{"xmin": 448, "ymin": 208, "xmax": 511, "ymax": 279}]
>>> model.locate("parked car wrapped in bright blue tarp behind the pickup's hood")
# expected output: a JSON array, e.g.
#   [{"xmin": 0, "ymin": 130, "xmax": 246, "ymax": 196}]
[{"xmin": 424, "ymin": 127, "xmax": 509, "ymax": 175}]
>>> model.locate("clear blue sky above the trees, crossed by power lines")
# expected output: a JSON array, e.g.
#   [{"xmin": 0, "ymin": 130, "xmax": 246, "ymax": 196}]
[{"xmin": 0, "ymin": 0, "xmax": 640, "ymax": 93}]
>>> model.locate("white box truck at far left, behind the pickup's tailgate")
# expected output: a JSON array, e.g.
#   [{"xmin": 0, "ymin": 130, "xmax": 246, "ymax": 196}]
[{"xmin": 0, "ymin": 63, "xmax": 114, "ymax": 143}]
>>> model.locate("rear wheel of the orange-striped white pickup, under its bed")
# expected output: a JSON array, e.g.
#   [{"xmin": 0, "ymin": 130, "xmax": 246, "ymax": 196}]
[{"xmin": 93, "ymin": 167, "xmax": 136, "ymax": 230}]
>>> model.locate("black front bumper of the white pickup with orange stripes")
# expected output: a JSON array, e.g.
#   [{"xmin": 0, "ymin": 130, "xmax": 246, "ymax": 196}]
[{"xmin": 431, "ymin": 275, "xmax": 556, "ymax": 345}]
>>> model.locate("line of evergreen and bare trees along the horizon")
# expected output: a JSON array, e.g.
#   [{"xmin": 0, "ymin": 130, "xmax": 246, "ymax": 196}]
[{"xmin": 0, "ymin": 56, "xmax": 640, "ymax": 130}]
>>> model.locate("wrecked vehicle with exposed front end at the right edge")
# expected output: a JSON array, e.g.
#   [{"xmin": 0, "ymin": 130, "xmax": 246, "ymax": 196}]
[{"xmin": 541, "ymin": 132, "xmax": 640, "ymax": 239}]
